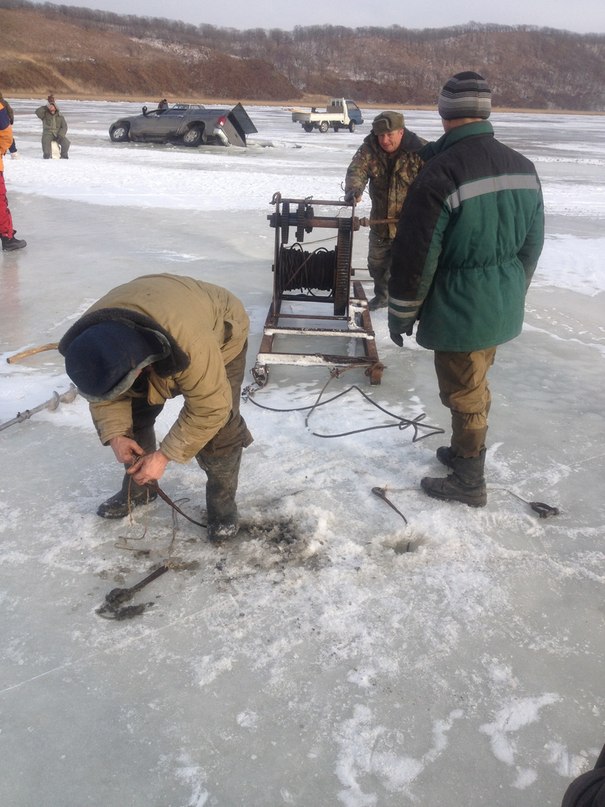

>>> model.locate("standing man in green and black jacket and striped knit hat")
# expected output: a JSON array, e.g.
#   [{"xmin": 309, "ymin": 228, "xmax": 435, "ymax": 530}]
[{"xmin": 388, "ymin": 71, "xmax": 544, "ymax": 507}]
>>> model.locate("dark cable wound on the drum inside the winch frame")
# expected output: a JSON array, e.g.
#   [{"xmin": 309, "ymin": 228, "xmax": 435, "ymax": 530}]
[{"xmin": 275, "ymin": 248, "xmax": 336, "ymax": 294}]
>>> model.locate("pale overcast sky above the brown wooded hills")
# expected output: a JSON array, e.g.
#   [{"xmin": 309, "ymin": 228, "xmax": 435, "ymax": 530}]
[{"xmin": 37, "ymin": 0, "xmax": 605, "ymax": 33}]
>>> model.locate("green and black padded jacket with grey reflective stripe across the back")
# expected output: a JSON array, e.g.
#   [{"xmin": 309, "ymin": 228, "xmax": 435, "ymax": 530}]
[{"xmin": 392, "ymin": 121, "xmax": 544, "ymax": 351}]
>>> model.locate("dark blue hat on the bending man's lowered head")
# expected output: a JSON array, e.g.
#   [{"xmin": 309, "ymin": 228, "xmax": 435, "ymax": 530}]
[{"xmin": 65, "ymin": 321, "xmax": 169, "ymax": 402}]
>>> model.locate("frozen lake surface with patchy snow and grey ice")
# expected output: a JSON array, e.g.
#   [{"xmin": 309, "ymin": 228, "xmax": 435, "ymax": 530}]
[{"xmin": 0, "ymin": 100, "xmax": 605, "ymax": 807}]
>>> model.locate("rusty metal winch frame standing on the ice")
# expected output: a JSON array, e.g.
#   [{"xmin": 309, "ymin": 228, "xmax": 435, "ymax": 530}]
[{"xmin": 252, "ymin": 193, "xmax": 384, "ymax": 387}]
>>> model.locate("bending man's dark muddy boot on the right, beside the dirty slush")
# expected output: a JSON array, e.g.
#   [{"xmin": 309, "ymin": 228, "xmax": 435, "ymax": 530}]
[{"xmin": 196, "ymin": 446, "xmax": 242, "ymax": 541}]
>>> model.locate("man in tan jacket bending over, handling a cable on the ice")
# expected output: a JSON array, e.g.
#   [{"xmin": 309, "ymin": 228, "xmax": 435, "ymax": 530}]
[{"xmin": 59, "ymin": 274, "xmax": 252, "ymax": 541}]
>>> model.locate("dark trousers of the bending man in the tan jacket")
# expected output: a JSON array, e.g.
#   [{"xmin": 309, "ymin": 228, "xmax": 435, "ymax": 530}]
[{"xmin": 132, "ymin": 342, "xmax": 254, "ymax": 457}]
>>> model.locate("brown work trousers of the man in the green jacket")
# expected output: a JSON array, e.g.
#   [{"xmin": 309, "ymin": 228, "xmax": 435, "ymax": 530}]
[{"xmin": 435, "ymin": 347, "xmax": 496, "ymax": 457}]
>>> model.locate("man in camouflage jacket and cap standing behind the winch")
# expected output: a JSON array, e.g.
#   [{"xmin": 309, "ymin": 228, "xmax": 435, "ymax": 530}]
[{"xmin": 345, "ymin": 112, "xmax": 426, "ymax": 311}]
